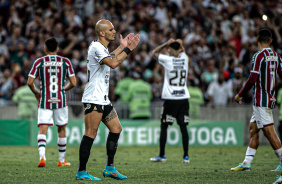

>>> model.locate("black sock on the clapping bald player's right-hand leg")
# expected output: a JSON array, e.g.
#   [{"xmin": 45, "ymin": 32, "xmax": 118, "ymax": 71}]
[{"xmin": 106, "ymin": 132, "xmax": 120, "ymax": 166}]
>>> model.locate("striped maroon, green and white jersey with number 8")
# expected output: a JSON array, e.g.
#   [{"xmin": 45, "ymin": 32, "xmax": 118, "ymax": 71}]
[{"xmin": 28, "ymin": 55, "xmax": 74, "ymax": 109}]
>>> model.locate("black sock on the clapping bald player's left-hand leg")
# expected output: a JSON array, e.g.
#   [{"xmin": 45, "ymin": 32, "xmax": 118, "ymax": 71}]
[{"xmin": 78, "ymin": 135, "xmax": 94, "ymax": 171}]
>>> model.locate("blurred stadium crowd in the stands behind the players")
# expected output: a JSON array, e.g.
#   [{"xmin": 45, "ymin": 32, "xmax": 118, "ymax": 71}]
[{"xmin": 0, "ymin": 0, "xmax": 282, "ymax": 106}]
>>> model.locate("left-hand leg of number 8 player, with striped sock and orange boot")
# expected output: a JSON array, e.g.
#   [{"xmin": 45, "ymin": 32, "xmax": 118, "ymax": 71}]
[{"xmin": 37, "ymin": 125, "xmax": 48, "ymax": 167}]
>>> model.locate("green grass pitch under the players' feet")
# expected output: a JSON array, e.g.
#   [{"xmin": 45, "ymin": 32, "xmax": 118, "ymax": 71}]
[{"xmin": 0, "ymin": 146, "xmax": 280, "ymax": 184}]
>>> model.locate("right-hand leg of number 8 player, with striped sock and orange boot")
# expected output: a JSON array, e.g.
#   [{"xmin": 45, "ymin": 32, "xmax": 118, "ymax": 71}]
[{"xmin": 57, "ymin": 126, "xmax": 71, "ymax": 167}]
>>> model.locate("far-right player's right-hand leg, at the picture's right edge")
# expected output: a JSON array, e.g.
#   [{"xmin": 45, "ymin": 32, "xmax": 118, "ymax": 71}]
[{"xmin": 263, "ymin": 125, "xmax": 282, "ymax": 171}]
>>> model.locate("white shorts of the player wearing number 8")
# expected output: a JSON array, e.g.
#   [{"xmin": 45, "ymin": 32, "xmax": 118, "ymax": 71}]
[{"xmin": 37, "ymin": 106, "xmax": 68, "ymax": 126}]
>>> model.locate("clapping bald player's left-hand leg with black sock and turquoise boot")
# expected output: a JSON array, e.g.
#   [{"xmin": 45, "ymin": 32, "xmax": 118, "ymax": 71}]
[{"xmin": 76, "ymin": 111, "xmax": 103, "ymax": 180}]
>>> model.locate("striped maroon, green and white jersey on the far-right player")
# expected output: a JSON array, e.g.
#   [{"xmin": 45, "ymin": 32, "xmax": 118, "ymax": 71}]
[{"xmin": 251, "ymin": 48, "xmax": 282, "ymax": 109}]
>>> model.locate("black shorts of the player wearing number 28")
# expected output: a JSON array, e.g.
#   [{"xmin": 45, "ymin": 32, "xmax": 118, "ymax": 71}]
[{"xmin": 161, "ymin": 99, "xmax": 189, "ymax": 125}]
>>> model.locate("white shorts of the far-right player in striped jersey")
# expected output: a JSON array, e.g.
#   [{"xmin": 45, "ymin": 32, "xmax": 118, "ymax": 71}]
[{"xmin": 250, "ymin": 106, "xmax": 274, "ymax": 129}]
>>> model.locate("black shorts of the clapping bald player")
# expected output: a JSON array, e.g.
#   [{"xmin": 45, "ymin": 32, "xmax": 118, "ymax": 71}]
[{"xmin": 83, "ymin": 103, "xmax": 114, "ymax": 119}]
